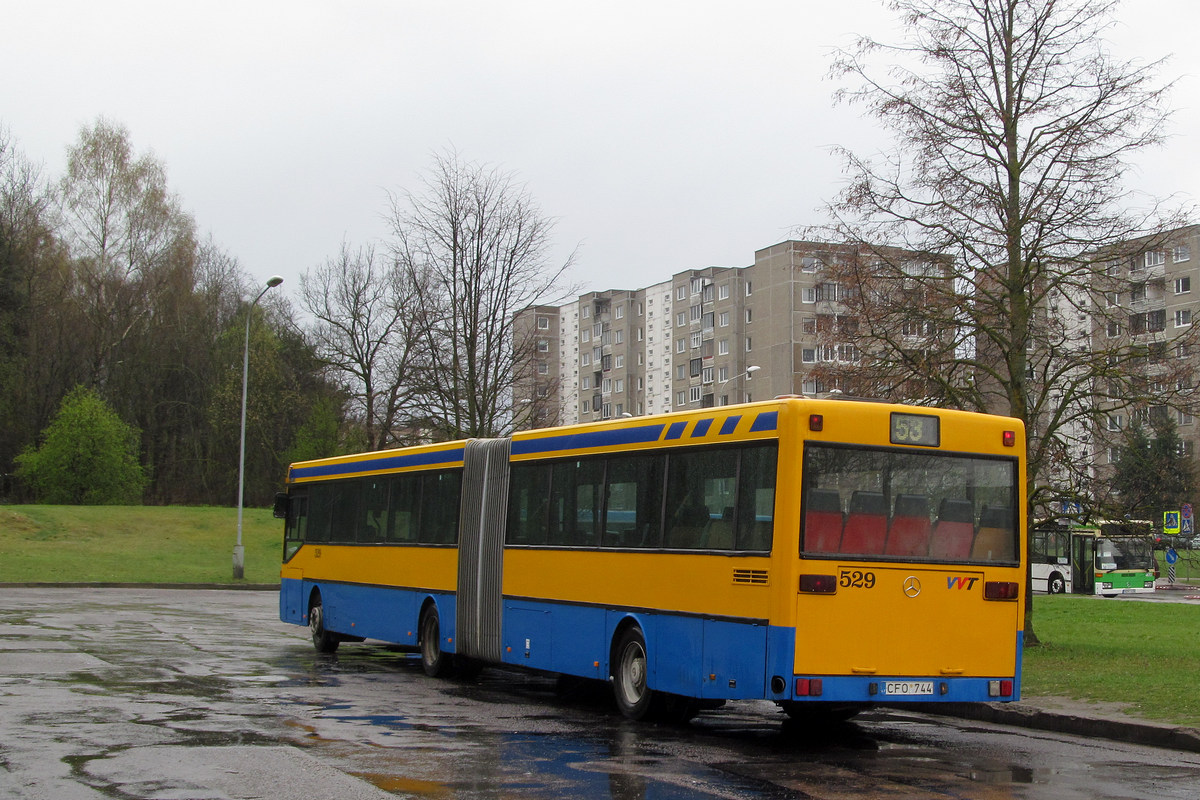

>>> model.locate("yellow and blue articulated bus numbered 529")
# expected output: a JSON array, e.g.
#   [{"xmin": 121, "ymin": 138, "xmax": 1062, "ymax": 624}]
[{"xmin": 276, "ymin": 398, "xmax": 1025, "ymax": 718}]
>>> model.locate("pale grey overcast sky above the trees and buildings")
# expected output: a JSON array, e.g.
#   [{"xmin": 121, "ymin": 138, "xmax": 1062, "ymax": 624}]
[{"xmin": 0, "ymin": 0, "xmax": 1200, "ymax": 294}]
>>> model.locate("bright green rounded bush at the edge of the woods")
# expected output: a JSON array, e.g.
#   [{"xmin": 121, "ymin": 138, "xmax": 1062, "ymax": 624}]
[{"xmin": 17, "ymin": 386, "xmax": 146, "ymax": 505}]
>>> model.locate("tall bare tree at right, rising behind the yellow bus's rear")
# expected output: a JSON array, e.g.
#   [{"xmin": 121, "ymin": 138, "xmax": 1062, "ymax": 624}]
[{"xmin": 833, "ymin": 0, "xmax": 1178, "ymax": 643}]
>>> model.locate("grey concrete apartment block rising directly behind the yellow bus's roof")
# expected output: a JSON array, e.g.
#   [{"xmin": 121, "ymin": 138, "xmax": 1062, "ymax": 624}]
[{"xmin": 515, "ymin": 241, "xmax": 878, "ymax": 428}]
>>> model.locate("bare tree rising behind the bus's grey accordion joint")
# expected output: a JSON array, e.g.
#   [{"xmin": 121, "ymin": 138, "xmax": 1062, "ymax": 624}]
[{"xmin": 390, "ymin": 154, "xmax": 572, "ymax": 438}]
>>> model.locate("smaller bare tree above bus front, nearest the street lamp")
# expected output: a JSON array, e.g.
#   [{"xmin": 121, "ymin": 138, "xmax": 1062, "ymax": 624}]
[{"xmin": 300, "ymin": 245, "xmax": 427, "ymax": 450}]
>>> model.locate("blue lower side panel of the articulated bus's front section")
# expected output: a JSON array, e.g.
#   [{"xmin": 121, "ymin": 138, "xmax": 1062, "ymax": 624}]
[{"xmin": 280, "ymin": 579, "xmax": 455, "ymax": 652}]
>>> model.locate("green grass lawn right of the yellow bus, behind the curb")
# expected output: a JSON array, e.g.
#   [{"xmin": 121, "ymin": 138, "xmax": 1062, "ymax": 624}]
[{"xmin": 1021, "ymin": 595, "xmax": 1200, "ymax": 727}]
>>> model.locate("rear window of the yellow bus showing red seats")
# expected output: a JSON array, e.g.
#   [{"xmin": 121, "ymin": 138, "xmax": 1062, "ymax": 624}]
[{"xmin": 800, "ymin": 443, "xmax": 1020, "ymax": 564}]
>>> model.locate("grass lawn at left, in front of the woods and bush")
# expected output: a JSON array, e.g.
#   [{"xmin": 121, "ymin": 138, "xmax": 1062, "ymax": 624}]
[{"xmin": 0, "ymin": 505, "xmax": 283, "ymax": 584}]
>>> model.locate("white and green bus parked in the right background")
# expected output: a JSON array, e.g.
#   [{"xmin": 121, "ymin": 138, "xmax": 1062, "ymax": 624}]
[{"xmin": 1030, "ymin": 519, "xmax": 1154, "ymax": 597}]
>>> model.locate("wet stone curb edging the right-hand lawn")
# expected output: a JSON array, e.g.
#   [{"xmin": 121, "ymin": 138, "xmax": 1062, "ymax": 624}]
[{"xmin": 907, "ymin": 702, "xmax": 1200, "ymax": 753}]
